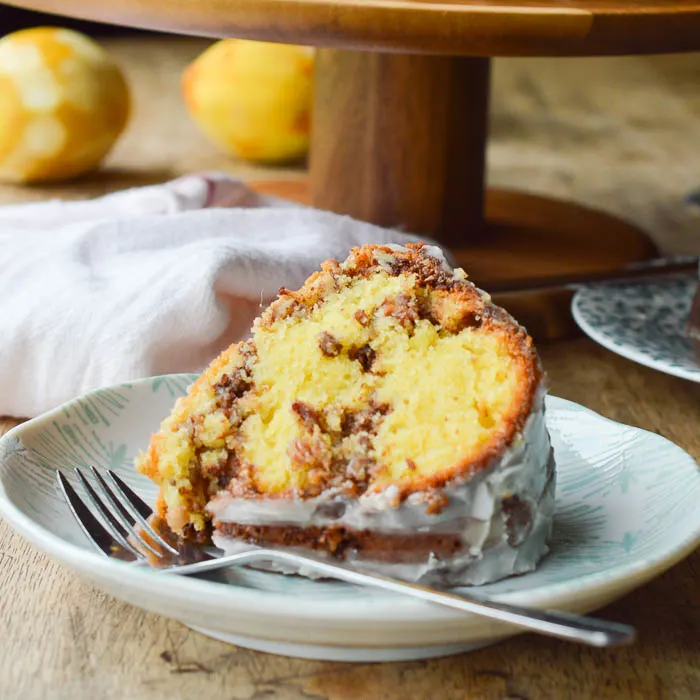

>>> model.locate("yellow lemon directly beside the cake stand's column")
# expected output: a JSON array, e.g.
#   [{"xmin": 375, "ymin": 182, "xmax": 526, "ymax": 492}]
[{"xmin": 182, "ymin": 39, "xmax": 313, "ymax": 163}]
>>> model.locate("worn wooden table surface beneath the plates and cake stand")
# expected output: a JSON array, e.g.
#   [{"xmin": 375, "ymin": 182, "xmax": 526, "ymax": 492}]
[{"xmin": 0, "ymin": 38, "xmax": 700, "ymax": 700}]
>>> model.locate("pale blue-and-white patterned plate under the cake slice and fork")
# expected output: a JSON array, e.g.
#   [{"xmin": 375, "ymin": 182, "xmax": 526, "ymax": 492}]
[{"xmin": 0, "ymin": 375, "xmax": 700, "ymax": 661}]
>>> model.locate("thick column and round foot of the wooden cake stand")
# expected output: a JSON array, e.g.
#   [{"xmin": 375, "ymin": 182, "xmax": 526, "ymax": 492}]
[{"xmin": 258, "ymin": 49, "xmax": 655, "ymax": 340}]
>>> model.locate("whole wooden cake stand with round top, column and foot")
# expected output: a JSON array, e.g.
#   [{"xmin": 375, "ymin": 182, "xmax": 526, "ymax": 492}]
[{"xmin": 10, "ymin": 0, "xmax": 700, "ymax": 338}]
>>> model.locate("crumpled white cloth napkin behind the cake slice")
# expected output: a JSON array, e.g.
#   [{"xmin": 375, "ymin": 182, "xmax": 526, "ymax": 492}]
[{"xmin": 0, "ymin": 174, "xmax": 424, "ymax": 417}]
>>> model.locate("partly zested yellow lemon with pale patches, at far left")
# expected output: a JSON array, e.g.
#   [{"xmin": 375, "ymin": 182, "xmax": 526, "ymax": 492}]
[{"xmin": 0, "ymin": 27, "xmax": 129, "ymax": 182}]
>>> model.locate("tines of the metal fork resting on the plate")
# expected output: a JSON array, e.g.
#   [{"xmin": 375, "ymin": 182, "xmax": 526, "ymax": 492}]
[{"xmin": 56, "ymin": 467, "xmax": 178, "ymax": 560}]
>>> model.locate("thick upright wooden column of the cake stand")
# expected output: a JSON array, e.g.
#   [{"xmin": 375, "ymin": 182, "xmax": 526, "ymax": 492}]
[{"xmin": 311, "ymin": 49, "xmax": 489, "ymax": 246}]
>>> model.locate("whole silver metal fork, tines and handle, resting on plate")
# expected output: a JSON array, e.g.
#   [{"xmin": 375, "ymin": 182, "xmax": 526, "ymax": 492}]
[{"xmin": 56, "ymin": 467, "xmax": 635, "ymax": 647}]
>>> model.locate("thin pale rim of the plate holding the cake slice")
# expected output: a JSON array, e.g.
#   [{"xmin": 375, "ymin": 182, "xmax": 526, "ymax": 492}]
[{"xmin": 0, "ymin": 373, "xmax": 700, "ymax": 632}]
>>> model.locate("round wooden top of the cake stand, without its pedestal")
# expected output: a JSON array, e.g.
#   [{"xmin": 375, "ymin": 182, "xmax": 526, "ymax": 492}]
[{"xmin": 8, "ymin": 0, "xmax": 700, "ymax": 56}]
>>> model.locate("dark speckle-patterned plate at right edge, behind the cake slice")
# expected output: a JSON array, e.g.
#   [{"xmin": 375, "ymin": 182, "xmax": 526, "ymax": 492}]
[{"xmin": 571, "ymin": 278, "xmax": 700, "ymax": 382}]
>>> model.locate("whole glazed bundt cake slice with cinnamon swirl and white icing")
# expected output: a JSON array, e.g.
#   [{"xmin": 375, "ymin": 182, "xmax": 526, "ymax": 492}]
[{"xmin": 137, "ymin": 244, "xmax": 554, "ymax": 585}]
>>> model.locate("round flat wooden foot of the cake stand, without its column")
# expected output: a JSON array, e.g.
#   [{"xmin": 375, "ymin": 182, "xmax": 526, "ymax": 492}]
[{"xmin": 251, "ymin": 179, "xmax": 657, "ymax": 341}]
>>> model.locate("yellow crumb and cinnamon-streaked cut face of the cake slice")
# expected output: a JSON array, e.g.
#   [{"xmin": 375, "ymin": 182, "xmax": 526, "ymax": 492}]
[{"xmin": 137, "ymin": 246, "xmax": 540, "ymax": 533}]
